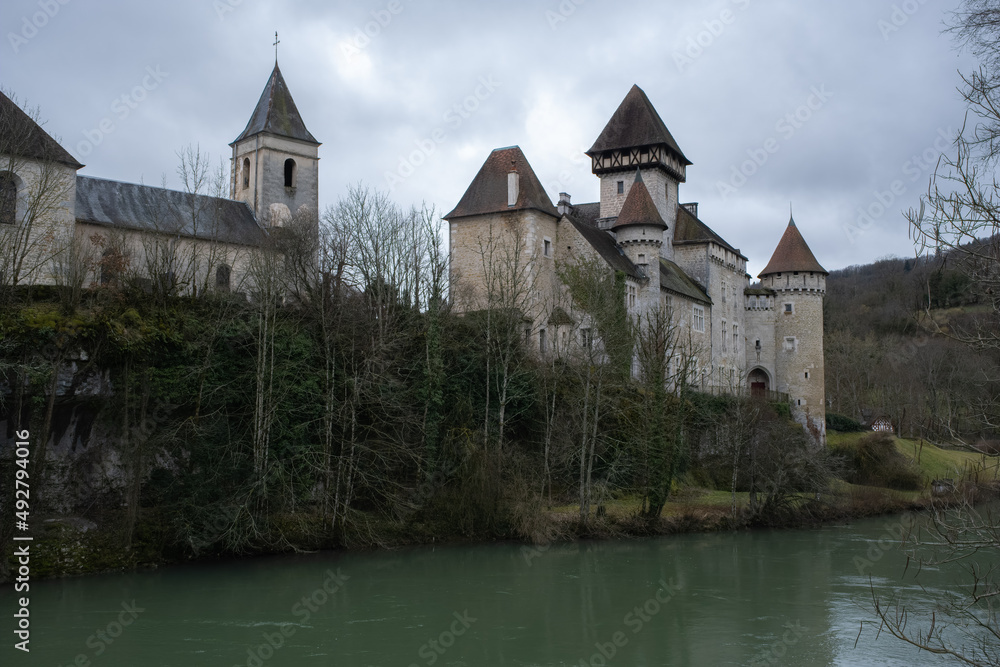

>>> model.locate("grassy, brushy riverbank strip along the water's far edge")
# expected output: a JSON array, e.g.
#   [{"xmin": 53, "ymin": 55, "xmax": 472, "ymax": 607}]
[{"xmin": 13, "ymin": 441, "xmax": 1000, "ymax": 579}]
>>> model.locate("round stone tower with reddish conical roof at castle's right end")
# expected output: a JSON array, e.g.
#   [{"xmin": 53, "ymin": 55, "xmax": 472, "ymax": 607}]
[{"xmin": 748, "ymin": 219, "xmax": 829, "ymax": 444}]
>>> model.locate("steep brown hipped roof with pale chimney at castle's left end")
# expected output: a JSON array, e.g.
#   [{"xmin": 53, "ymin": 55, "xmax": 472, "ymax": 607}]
[{"xmin": 444, "ymin": 146, "xmax": 559, "ymax": 220}]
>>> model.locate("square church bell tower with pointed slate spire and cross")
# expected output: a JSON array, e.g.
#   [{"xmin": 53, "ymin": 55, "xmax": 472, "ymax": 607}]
[{"xmin": 229, "ymin": 61, "xmax": 320, "ymax": 227}]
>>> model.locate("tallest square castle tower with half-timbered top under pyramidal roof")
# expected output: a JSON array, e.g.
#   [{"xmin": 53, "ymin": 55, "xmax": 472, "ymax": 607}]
[{"xmin": 587, "ymin": 86, "xmax": 691, "ymax": 259}]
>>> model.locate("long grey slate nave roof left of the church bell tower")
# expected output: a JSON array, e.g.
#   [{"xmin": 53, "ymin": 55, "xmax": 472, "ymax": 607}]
[{"xmin": 76, "ymin": 176, "xmax": 267, "ymax": 245}]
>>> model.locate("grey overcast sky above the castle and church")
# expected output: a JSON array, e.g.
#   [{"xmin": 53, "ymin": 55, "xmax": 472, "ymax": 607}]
[{"xmin": 0, "ymin": 0, "xmax": 974, "ymax": 274}]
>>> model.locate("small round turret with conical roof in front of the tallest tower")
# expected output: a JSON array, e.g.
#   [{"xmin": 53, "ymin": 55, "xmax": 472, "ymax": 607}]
[{"xmin": 611, "ymin": 168, "xmax": 667, "ymax": 314}]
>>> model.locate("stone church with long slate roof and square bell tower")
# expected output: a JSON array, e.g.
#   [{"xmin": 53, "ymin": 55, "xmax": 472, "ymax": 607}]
[{"xmin": 0, "ymin": 61, "xmax": 320, "ymax": 295}]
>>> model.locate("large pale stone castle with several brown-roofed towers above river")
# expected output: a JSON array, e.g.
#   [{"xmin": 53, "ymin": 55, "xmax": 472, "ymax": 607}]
[{"xmin": 444, "ymin": 86, "xmax": 828, "ymax": 443}]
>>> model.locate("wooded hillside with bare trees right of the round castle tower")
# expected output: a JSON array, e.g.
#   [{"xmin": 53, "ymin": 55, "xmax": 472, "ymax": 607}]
[{"xmin": 825, "ymin": 247, "xmax": 1000, "ymax": 443}]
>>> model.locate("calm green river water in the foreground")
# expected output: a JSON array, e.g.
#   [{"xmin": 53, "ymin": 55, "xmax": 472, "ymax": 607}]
[{"xmin": 0, "ymin": 518, "xmax": 984, "ymax": 667}]
